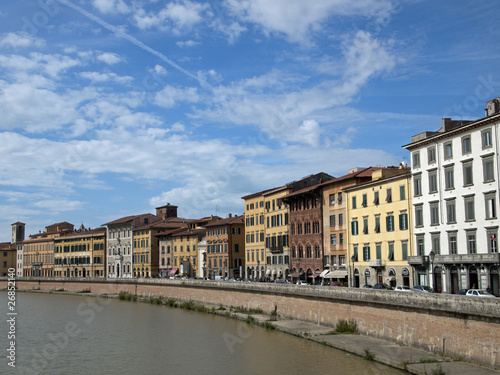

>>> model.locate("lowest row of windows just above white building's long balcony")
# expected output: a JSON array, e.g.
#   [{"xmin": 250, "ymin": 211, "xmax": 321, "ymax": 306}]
[{"xmin": 415, "ymin": 228, "xmax": 498, "ymax": 255}]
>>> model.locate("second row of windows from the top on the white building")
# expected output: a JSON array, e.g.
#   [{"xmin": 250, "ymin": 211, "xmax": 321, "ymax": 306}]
[{"xmin": 413, "ymin": 156, "xmax": 495, "ymax": 196}]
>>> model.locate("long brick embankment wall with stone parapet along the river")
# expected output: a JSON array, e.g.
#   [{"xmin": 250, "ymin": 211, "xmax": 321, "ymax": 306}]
[{"xmin": 0, "ymin": 278, "xmax": 500, "ymax": 368}]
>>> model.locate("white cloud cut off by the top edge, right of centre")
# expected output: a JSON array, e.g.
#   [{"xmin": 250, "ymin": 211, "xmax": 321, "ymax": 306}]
[{"xmin": 226, "ymin": 0, "xmax": 392, "ymax": 43}]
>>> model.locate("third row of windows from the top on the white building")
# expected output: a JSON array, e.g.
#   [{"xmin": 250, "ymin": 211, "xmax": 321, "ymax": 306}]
[{"xmin": 415, "ymin": 192, "xmax": 497, "ymax": 228}]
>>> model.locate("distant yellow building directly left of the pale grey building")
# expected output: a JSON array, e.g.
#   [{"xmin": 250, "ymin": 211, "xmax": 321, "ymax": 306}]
[{"xmin": 54, "ymin": 225, "xmax": 106, "ymax": 277}]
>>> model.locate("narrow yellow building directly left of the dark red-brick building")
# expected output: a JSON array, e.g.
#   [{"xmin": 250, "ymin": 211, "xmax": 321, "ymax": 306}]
[{"xmin": 262, "ymin": 186, "xmax": 292, "ymax": 280}]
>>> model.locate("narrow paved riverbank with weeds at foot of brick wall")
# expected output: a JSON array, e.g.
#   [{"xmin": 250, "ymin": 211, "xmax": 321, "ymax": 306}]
[{"xmin": 13, "ymin": 289, "xmax": 500, "ymax": 375}]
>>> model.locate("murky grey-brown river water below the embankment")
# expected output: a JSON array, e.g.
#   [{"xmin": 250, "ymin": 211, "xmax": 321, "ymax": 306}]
[{"xmin": 0, "ymin": 292, "xmax": 403, "ymax": 375}]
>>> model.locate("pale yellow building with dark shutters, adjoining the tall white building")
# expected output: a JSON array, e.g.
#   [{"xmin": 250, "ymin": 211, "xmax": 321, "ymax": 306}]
[{"xmin": 344, "ymin": 167, "xmax": 413, "ymax": 287}]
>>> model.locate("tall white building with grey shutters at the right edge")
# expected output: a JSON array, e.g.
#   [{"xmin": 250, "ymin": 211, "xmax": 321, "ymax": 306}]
[{"xmin": 403, "ymin": 99, "xmax": 500, "ymax": 294}]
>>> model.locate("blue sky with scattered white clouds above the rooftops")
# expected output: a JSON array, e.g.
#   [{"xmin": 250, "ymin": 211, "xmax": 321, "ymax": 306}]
[{"xmin": 0, "ymin": 0, "xmax": 500, "ymax": 242}]
